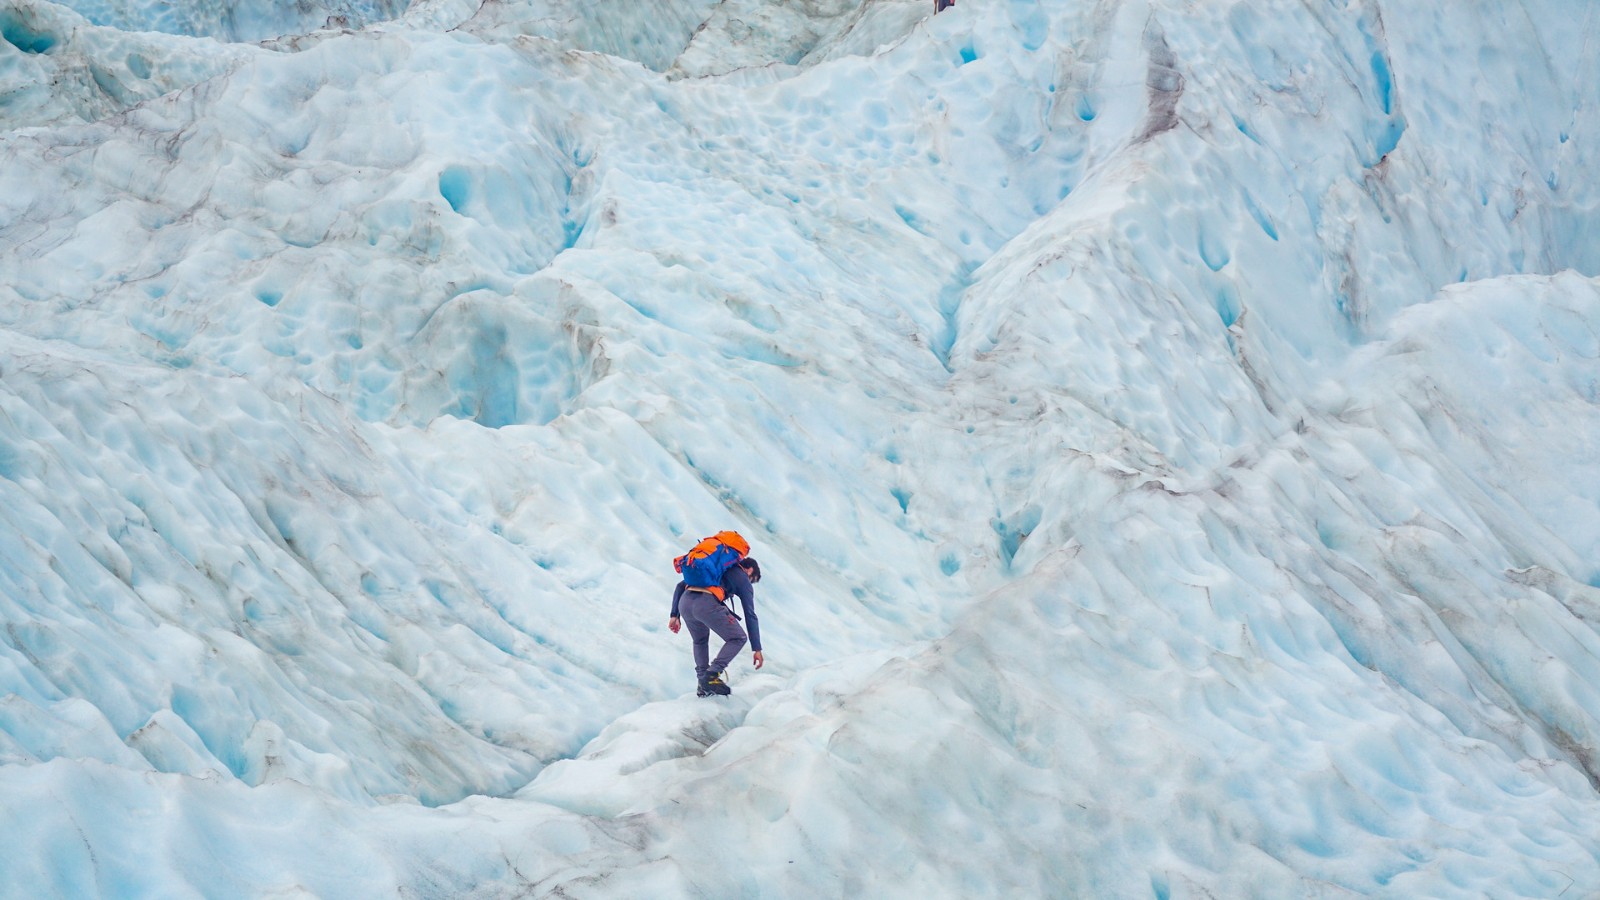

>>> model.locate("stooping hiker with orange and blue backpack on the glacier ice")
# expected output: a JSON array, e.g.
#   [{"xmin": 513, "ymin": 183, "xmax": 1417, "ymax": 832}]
[{"xmin": 667, "ymin": 532, "xmax": 766, "ymax": 697}]
